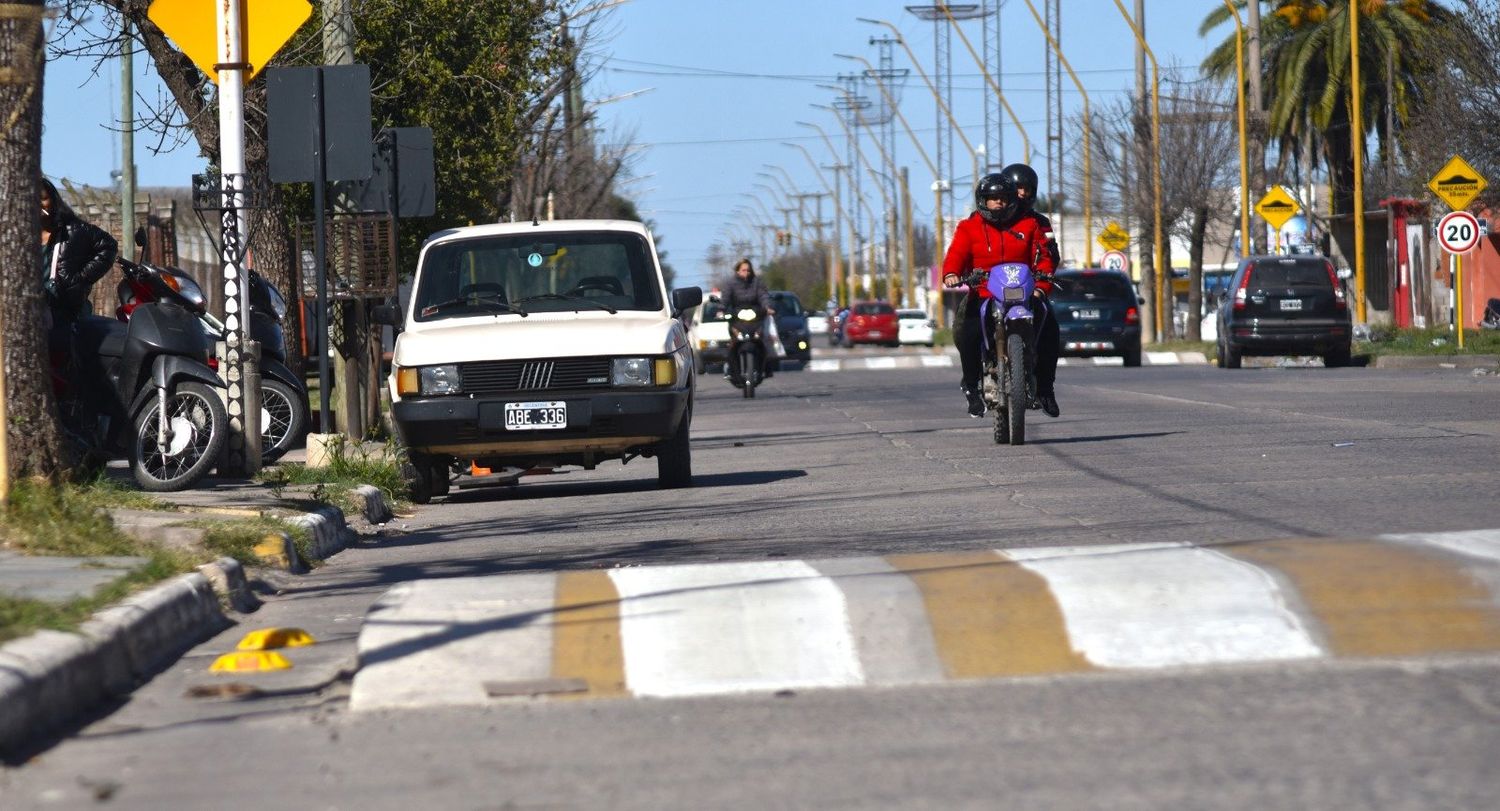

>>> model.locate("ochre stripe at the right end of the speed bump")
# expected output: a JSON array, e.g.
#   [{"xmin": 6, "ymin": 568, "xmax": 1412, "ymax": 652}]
[{"xmin": 1214, "ymin": 538, "xmax": 1500, "ymax": 657}]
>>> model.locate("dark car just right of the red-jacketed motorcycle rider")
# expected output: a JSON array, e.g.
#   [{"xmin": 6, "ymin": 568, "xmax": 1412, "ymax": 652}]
[{"xmin": 1049, "ymin": 268, "xmax": 1142, "ymax": 366}]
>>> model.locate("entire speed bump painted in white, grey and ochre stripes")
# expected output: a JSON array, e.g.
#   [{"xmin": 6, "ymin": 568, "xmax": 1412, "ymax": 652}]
[{"xmin": 351, "ymin": 531, "xmax": 1500, "ymax": 711}]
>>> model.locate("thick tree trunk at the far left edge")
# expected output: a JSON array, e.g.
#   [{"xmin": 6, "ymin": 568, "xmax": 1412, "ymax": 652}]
[{"xmin": 0, "ymin": 0, "xmax": 68, "ymax": 481}]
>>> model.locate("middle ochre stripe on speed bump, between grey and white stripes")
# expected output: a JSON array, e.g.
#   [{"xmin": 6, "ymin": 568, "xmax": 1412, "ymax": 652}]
[{"xmin": 885, "ymin": 552, "xmax": 1094, "ymax": 679}]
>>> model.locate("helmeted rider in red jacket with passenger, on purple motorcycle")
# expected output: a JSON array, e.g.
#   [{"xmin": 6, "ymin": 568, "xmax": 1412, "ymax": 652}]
[{"xmin": 942, "ymin": 163, "xmax": 1062, "ymax": 417}]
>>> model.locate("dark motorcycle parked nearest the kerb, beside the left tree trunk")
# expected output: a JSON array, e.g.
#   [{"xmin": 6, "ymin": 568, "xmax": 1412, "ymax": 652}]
[{"xmin": 53, "ymin": 259, "xmax": 230, "ymax": 492}]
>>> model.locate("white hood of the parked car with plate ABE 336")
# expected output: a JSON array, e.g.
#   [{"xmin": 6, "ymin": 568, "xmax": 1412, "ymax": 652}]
[{"xmin": 393, "ymin": 312, "xmax": 687, "ymax": 366}]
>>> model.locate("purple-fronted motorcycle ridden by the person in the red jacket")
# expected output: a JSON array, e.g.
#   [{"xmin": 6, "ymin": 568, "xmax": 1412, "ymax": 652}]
[{"xmin": 968, "ymin": 262, "xmax": 1037, "ymax": 445}]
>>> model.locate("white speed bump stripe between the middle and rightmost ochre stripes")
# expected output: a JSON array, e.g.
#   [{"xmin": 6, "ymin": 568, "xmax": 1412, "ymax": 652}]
[{"xmin": 1001, "ymin": 544, "xmax": 1323, "ymax": 667}]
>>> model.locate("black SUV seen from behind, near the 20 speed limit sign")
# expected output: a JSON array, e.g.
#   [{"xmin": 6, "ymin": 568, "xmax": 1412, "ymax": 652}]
[{"xmin": 1218, "ymin": 256, "xmax": 1353, "ymax": 369}]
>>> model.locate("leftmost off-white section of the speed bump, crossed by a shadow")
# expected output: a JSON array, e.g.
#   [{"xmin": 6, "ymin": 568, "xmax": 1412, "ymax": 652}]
[{"xmin": 350, "ymin": 574, "xmax": 557, "ymax": 711}]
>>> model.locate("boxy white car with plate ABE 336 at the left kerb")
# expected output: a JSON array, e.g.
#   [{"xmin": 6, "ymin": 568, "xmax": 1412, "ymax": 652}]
[{"xmin": 377, "ymin": 220, "xmax": 704, "ymax": 504}]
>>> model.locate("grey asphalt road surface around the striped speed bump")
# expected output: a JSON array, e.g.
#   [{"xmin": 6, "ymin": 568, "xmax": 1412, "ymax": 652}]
[{"xmin": 0, "ymin": 367, "xmax": 1500, "ymax": 810}]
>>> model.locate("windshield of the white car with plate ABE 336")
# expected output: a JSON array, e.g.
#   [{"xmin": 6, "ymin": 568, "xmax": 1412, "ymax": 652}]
[{"xmin": 416, "ymin": 231, "xmax": 662, "ymax": 321}]
